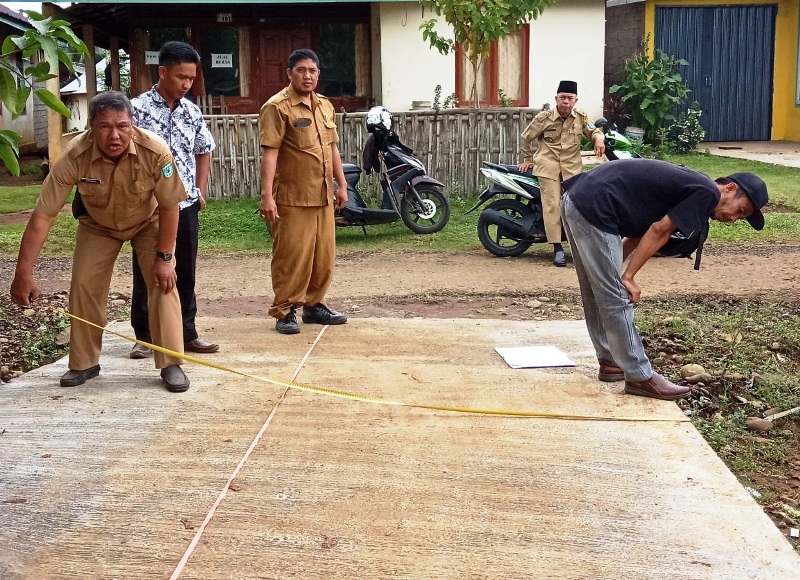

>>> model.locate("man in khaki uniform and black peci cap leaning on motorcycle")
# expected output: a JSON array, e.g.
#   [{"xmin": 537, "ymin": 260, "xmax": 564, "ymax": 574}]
[{"xmin": 519, "ymin": 81, "xmax": 606, "ymax": 266}]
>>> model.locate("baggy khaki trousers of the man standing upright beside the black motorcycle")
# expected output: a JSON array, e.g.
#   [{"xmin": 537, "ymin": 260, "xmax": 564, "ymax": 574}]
[{"xmin": 269, "ymin": 204, "xmax": 336, "ymax": 319}]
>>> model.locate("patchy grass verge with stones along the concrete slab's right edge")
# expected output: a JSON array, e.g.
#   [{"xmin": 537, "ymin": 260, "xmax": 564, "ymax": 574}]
[{"xmin": 636, "ymin": 296, "xmax": 800, "ymax": 481}]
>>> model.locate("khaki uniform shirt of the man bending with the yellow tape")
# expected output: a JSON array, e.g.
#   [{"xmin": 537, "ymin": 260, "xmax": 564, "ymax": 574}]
[{"xmin": 36, "ymin": 127, "xmax": 186, "ymax": 239}]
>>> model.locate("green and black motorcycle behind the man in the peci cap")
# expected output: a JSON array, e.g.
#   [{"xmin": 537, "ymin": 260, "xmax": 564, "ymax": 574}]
[{"xmin": 466, "ymin": 117, "xmax": 640, "ymax": 258}]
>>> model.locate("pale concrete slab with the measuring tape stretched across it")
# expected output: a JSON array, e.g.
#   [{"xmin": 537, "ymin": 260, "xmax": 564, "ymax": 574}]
[{"xmin": 0, "ymin": 319, "xmax": 800, "ymax": 578}]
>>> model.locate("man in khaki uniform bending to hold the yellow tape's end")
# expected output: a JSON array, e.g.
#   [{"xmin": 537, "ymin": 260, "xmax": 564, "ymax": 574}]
[{"xmin": 11, "ymin": 92, "xmax": 189, "ymax": 392}]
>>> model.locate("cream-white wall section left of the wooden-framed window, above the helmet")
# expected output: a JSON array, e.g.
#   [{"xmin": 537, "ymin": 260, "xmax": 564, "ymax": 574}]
[{"xmin": 375, "ymin": 2, "xmax": 456, "ymax": 111}]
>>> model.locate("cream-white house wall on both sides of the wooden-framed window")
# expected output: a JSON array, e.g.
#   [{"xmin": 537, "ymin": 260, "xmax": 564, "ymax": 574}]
[{"xmin": 373, "ymin": 0, "xmax": 605, "ymax": 118}]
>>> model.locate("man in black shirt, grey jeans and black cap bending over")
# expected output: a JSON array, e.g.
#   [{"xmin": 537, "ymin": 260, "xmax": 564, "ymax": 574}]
[{"xmin": 561, "ymin": 159, "xmax": 769, "ymax": 400}]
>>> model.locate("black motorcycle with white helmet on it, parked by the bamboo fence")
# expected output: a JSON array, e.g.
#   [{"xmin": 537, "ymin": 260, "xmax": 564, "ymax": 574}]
[{"xmin": 336, "ymin": 107, "xmax": 450, "ymax": 234}]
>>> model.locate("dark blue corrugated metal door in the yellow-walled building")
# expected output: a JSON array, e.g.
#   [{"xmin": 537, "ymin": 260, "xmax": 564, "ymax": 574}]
[{"xmin": 655, "ymin": 5, "xmax": 777, "ymax": 141}]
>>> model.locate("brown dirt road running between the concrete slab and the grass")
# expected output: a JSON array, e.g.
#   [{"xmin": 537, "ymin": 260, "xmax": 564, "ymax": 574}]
[{"xmin": 0, "ymin": 244, "xmax": 800, "ymax": 318}]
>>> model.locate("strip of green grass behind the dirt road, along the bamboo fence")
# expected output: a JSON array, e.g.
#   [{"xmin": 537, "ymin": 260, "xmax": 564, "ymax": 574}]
[{"xmin": 0, "ymin": 154, "xmax": 800, "ymax": 256}]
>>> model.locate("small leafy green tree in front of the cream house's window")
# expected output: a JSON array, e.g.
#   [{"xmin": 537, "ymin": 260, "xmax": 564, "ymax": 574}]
[{"xmin": 419, "ymin": 0, "xmax": 556, "ymax": 107}]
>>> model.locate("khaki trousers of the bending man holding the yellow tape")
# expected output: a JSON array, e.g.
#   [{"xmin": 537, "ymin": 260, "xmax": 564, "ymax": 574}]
[{"xmin": 69, "ymin": 220, "xmax": 183, "ymax": 371}]
